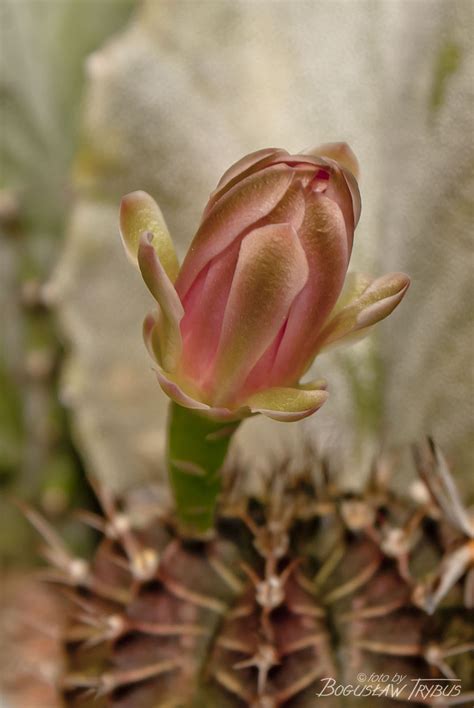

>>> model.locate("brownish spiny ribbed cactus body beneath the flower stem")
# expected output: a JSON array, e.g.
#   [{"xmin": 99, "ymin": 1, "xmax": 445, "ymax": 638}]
[{"xmin": 26, "ymin": 436, "xmax": 474, "ymax": 708}]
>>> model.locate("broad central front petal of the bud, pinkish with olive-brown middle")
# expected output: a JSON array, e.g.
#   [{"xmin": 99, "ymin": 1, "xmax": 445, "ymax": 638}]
[{"xmin": 210, "ymin": 224, "xmax": 308, "ymax": 401}]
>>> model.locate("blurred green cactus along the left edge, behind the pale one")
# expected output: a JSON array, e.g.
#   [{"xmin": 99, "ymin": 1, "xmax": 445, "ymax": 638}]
[{"xmin": 0, "ymin": 0, "xmax": 132, "ymax": 563}]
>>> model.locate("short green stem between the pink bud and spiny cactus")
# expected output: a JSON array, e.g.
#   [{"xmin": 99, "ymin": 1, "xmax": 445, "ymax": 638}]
[{"xmin": 167, "ymin": 403, "xmax": 239, "ymax": 537}]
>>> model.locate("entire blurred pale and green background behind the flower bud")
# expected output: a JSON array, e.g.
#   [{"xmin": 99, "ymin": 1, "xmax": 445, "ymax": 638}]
[{"xmin": 0, "ymin": 0, "xmax": 474, "ymax": 696}]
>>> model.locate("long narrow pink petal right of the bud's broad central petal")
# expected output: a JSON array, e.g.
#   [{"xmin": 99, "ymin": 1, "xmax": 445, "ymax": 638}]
[{"xmin": 272, "ymin": 194, "xmax": 349, "ymax": 385}]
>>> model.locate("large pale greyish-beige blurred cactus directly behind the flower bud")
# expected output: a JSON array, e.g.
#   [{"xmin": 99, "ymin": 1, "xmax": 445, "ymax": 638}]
[{"xmin": 51, "ymin": 0, "xmax": 472, "ymax": 498}]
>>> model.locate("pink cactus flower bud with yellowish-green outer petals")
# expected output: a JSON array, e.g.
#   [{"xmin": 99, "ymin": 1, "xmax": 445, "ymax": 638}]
[{"xmin": 120, "ymin": 143, "xmax": 409, "ymax": 421}]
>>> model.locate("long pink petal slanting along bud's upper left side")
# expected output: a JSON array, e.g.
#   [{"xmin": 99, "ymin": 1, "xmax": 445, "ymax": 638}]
[{"xmin": 176, "ymin": 165, "xmax": 293, "ymax": 299}]
